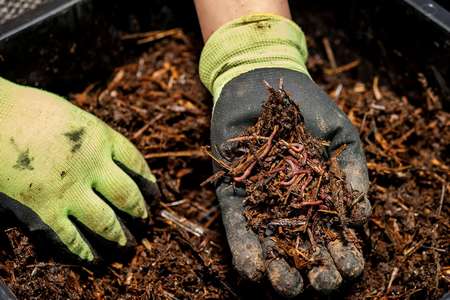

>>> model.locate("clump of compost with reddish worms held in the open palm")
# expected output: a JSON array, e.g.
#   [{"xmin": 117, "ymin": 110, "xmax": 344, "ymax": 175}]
[{"xmin": 216, "ymin": 84, "xmax": 364, "ymax": 269}]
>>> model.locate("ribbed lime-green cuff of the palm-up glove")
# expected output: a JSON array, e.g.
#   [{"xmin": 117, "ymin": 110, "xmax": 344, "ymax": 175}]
[{"xmin": 200, "ymin": 14, "xmax": 309, "ymax": 103}]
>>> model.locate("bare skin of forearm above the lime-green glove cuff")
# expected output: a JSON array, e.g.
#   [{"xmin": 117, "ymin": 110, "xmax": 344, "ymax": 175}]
[{"xmin": 194, "ymin": 0, "xmax": 291, "ymax": 41}]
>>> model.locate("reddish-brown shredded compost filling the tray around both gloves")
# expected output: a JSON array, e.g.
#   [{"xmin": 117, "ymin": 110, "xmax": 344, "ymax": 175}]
[{"xmin": 0, "ymin": 25, "xmax": 450, "ymax": 299}]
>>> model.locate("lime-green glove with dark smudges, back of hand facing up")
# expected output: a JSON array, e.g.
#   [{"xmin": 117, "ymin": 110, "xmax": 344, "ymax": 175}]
[{"xmin": 0, "ymin": 78, "xmax": 159, "ymax": 261}]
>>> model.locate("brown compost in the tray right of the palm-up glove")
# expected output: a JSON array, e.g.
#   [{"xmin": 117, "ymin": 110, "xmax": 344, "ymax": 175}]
[{"xmin": 308, "ymin": 37, "xmax": 450, "ymax": 299}]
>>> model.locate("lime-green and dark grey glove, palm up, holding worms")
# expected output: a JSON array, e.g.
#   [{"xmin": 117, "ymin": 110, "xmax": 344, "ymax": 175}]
[{"xmin": 200, "ymin": 14, "xmax": 371, "ymax": 297}]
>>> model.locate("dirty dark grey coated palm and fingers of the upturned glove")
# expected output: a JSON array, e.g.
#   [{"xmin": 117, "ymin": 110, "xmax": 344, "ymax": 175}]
[{"xmin": 211, "ymin": 69, "xmax": 370, "ymax": 297}]
